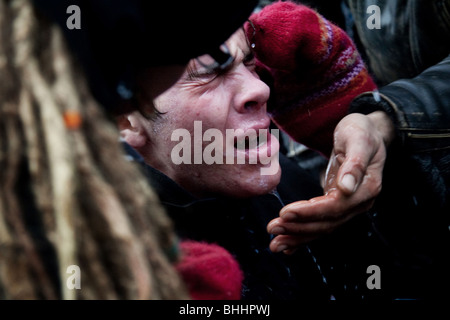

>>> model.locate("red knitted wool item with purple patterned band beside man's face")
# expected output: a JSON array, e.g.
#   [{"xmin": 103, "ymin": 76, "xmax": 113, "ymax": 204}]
[{"xmin": 245, "ymin": 2, "xmax": 376, "ymax": 156}]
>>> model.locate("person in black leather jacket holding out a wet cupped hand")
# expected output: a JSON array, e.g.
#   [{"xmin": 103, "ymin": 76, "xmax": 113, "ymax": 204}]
[{"xmin": 256, "ymin": 0, "xmax": 450, "ymax": 298}]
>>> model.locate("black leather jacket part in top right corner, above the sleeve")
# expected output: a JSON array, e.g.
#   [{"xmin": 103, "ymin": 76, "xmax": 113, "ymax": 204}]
[{"xmin": 347, "ymin": 0, "xmax": 450, "ymax": 85}]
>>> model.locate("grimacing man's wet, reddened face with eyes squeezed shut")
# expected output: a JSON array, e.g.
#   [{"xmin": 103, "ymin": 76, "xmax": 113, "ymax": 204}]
[{"xmin": 121, "ymin": 29, "xmax": 281, "ymax": 197}]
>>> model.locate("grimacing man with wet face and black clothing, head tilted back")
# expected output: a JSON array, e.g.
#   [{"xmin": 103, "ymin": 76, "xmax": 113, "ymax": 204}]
[{"xmin": 118, "ymin": 16, "xmax": 382, "ymax": 300}]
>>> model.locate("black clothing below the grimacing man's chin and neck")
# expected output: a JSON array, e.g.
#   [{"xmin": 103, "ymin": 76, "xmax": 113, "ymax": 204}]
[{"xmin": 127, "ymin": 146, "xmax": 332, "ymax": 301}]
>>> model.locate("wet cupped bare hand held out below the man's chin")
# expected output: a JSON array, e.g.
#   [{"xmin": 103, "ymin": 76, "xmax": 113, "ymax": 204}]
[{"xmin": 267, "ymin": 111, "xmax": 394, "ymax": 253}]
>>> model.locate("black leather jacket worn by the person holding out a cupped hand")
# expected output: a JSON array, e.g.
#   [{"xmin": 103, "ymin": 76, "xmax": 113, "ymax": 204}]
[{"xmin": 342, "ymin": 0, "xmax": 450, "ymax": 298}]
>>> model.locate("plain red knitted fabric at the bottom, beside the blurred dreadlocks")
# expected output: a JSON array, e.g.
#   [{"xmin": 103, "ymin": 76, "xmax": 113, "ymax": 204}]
[{"xmin": 176, "ymin": 241, "xmax": 243, "ymax": 300}]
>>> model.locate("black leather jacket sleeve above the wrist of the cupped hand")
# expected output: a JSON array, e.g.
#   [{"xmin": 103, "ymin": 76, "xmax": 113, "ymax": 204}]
[{"xmin": 350, "ymin": 56, "xmax": 450, "ymax": 153}]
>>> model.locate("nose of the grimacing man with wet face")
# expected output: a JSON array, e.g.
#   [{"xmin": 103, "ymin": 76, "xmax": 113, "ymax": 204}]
[{"xmin": 235, "ymin": 65, "xmax": 270, "ymax": 113}]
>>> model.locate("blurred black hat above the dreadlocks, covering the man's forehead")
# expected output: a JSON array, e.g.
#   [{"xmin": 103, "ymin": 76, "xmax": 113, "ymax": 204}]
[{"xmin": 33, "ymin": 0, "xmax": 258, "ymax": 113}]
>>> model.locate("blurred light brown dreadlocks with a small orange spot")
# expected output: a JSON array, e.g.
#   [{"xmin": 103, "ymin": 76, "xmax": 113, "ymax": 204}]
[{"xmin": 0, "ymin": 0, "xmax": 188, "ymax": 299}]
